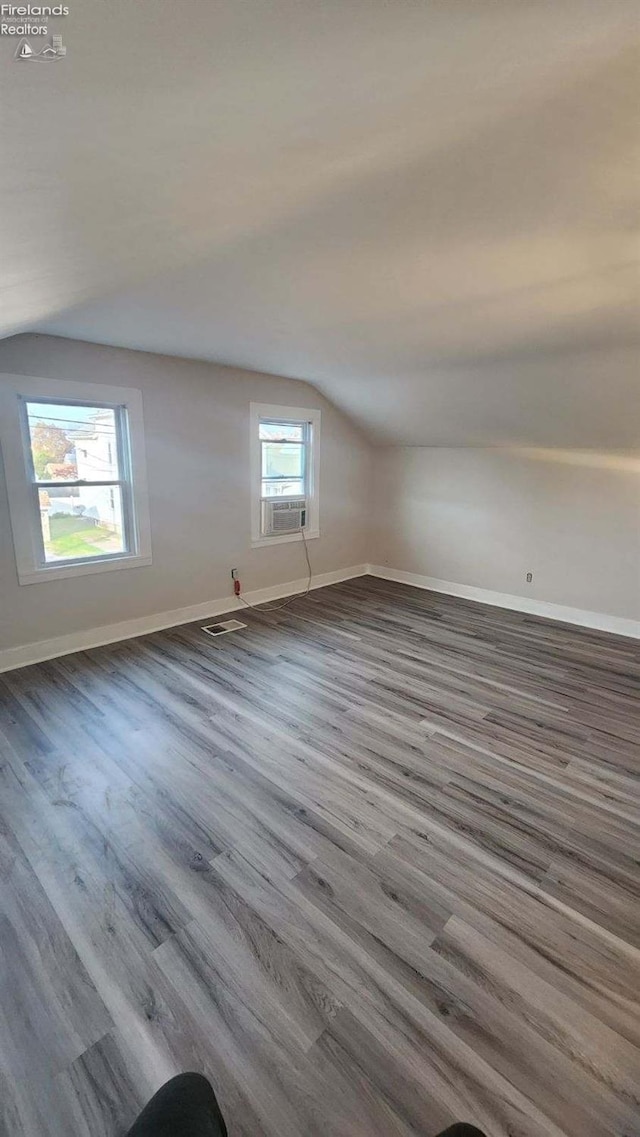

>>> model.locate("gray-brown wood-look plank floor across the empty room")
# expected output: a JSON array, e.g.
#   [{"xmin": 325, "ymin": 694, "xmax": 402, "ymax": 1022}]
[{"xmin": 0, "ymin": 578, "xmax": 640, "ymax": 1137}]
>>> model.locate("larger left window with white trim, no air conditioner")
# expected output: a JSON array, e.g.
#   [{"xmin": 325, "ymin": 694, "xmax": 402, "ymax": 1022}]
[{"xmin": 0, "ymin": 376, "xmax": 151, "ymax": 584}]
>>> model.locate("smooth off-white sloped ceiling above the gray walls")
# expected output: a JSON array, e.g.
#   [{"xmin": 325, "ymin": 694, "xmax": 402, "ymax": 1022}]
[{"xmin": 0, "ymin": 0, "xmax": 640, "ymax": 447}]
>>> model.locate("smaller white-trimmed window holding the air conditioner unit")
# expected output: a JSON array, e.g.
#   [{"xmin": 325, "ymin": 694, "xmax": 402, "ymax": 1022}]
[{"xmin": 250, "ymin": 402, "xmax": 321, "ymax": 546}]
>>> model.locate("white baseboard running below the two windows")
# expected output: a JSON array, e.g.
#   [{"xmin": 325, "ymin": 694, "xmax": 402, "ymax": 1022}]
[{"xmin": 0, "ymin": 565, "xmax": 368, "ymax": 672}]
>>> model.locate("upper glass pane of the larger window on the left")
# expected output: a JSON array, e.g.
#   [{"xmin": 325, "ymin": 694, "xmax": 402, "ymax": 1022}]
[{"xmin": 26, "ymin": 402, "xmax": 120, "ymax": 482}]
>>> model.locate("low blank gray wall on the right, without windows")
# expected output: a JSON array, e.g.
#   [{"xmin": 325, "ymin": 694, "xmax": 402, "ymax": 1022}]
[{"xmin": 369, "ymin": 447, "xmax": 640, "ymax": 620}]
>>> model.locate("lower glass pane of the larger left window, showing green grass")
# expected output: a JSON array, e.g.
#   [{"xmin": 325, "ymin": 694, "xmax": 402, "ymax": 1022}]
[{"xmin": 38, "ymin": 485, "xmax": 127, "ymax": 563}]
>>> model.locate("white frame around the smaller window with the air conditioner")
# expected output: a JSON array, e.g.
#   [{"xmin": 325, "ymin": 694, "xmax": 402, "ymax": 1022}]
[{"xmin": 249, "ymin": 402, "xmax": 322, "ymax": 549}]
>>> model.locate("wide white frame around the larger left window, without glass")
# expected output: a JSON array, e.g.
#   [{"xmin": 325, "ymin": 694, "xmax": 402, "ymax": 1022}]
[{"xmin": 0, "ymin": 374, "xmax": 151, "ymax": 584}]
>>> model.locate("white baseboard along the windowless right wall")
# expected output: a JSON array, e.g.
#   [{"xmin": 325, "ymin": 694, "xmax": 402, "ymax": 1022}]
[{"xmin": 366, "ymin": 565, "xmax": 640, "ymax": 639}]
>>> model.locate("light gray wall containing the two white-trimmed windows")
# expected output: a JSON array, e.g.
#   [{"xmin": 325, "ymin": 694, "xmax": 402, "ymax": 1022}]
[{"xmin": 0, "ymin": 335, "xmax": 372, "ymax": 648}]
